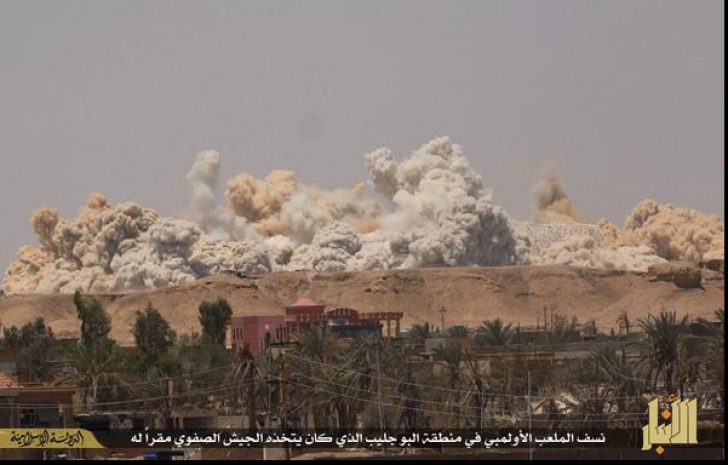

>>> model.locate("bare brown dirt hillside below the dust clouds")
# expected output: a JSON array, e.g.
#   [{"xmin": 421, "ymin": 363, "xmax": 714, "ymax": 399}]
[{"xmin": 0, "ymin": 266, "xmax": 725, "ymax": 344}]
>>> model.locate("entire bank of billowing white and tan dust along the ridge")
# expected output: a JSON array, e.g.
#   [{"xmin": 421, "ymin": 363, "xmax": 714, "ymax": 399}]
[{"xmin": 4, "ymin": 137, "xmax": 724, "ymax": 293}]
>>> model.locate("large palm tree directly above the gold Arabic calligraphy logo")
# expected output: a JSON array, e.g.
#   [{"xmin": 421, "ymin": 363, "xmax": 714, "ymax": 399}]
[{"xmin": 638, "ymin": 310, "xmax": 688, "ymax": 394}]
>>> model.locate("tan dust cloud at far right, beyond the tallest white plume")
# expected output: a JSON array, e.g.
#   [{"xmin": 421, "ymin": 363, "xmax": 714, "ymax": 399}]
[{"xmin": 526, "ymin": 174, "xmax": 724, "ymax": 271}]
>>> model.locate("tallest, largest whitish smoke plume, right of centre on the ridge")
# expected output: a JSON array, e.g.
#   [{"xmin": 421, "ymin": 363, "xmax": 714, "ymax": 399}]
[{"xmin": 365, "ymin": 137, "xmax": 519, "ymax": 267}]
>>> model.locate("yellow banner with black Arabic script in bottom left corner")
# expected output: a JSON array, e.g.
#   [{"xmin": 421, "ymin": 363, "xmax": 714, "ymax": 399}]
[{"xmin": 0, "ymin": 428, "xmax": 104, "ymax": 449}]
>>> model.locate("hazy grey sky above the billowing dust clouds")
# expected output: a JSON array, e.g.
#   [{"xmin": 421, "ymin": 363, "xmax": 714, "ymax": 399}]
[{"xmin": 0, "ymin": 0, "xmax": 725, "ymax": 270}]
